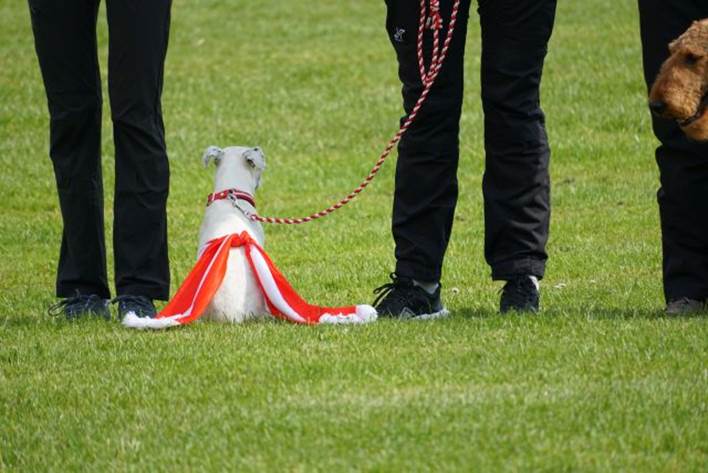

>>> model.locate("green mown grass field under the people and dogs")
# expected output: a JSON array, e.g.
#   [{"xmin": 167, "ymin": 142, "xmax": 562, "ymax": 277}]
[{"xmin": 0, "ymin": 0, "xmax": 708, "ymax": 472}]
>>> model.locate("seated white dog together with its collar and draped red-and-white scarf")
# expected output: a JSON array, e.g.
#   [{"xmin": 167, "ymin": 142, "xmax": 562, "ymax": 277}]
[{"xmin": 123, "ymin": 146, "xmax": 377, "ymax": 329}]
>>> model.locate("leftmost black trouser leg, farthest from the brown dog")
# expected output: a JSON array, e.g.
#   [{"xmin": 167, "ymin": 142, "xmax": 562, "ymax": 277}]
[{"xmin": 29, "ymin": 0, "xmax": 110, "ymax": 298}]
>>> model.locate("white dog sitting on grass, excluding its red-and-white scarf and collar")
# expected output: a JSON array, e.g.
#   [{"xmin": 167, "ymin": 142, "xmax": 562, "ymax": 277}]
[{"xmin": 199, "ymin": 146, "xmax": 268, "ymax": 323}]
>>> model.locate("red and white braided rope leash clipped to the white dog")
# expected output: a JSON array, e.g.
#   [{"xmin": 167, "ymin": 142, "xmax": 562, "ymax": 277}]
[{"xmin": 248, "ymin": 0, "xmax": 461, "ymax": 225}]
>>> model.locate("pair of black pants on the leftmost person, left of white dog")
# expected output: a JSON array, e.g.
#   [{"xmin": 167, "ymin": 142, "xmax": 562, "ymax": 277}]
[{"xmin": 29, "ymin": 0, "xmax": 171, "ymax": 299}]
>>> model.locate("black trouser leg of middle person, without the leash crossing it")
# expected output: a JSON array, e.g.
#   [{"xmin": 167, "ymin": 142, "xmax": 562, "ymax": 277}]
[{"xmin": 479, "ymin": 0, "xmax": 556, "ymax": 279}]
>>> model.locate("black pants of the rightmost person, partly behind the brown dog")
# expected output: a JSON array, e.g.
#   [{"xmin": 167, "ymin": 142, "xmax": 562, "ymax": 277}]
[{"xmin": 639, "ymin": 0, "xmax": 708, "ymax": 301}]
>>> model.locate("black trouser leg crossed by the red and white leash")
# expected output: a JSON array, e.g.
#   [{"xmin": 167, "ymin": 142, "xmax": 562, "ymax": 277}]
[{"xmin": 386, "ymin": 0, "xmax": 470, "ymax": 281}]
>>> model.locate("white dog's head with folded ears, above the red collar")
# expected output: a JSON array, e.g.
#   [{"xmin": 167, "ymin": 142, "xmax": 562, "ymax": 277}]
[{"xmin": 202, "ymin": 146, "xmax": 265, "ymax": 194}]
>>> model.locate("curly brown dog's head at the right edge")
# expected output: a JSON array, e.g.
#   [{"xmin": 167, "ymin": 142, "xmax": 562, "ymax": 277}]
[{"xmin": 649, "ymin": 18, "xmax": 708, "ymax": 141}]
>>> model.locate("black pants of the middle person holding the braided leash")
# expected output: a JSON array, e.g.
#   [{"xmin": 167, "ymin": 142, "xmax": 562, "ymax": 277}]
[{"xmin": 386, "ymin": 0, "xmax": 556, "ymax": 281}]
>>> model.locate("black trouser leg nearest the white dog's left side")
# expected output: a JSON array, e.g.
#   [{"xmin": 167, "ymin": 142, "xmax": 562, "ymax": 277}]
[{"xmin": 107, "ymin": 0, "xmax": 171, "ymax": 299}]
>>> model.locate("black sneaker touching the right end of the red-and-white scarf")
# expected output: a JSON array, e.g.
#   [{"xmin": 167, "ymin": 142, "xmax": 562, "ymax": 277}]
[{"xmin": 374, "ymin": 273, "xmax": 449, "ymax": 320}]
